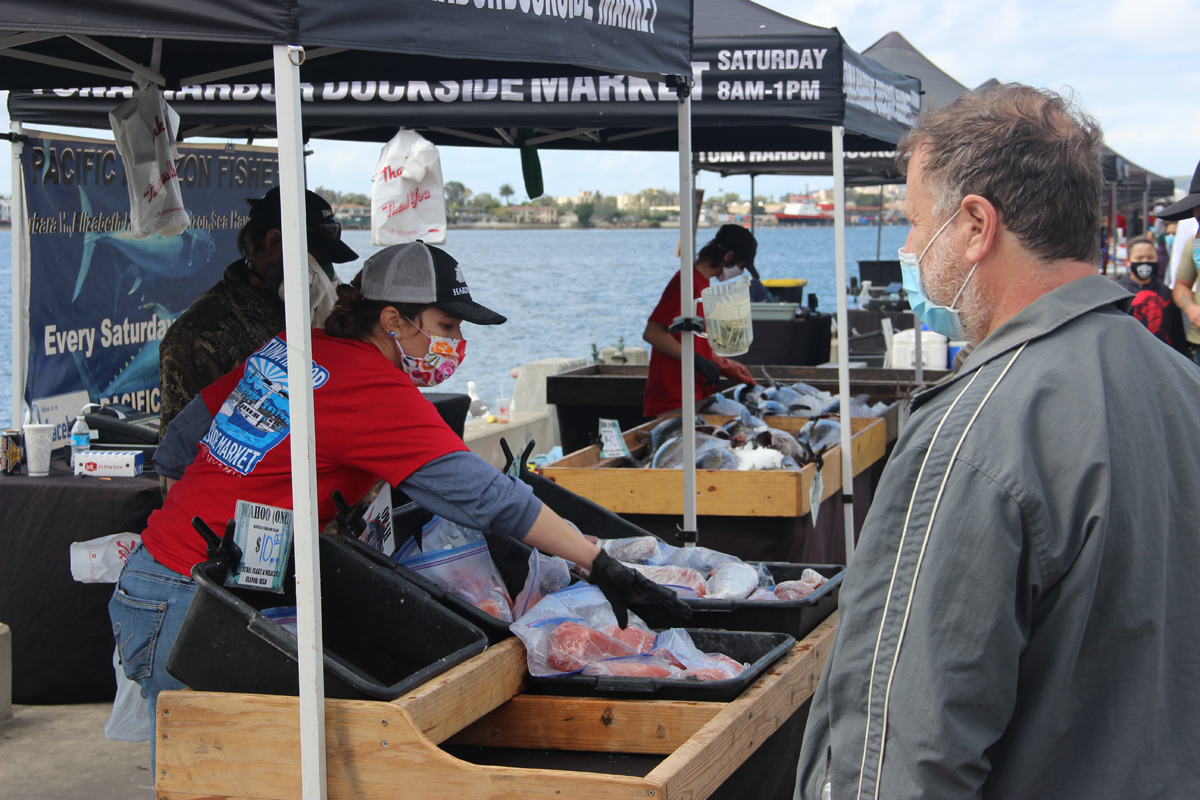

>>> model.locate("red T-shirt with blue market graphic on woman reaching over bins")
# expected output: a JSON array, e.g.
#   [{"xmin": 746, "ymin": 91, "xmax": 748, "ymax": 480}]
[{"xmin": 142, "ymin": 330, "xmax": 467, "ymax": 575}]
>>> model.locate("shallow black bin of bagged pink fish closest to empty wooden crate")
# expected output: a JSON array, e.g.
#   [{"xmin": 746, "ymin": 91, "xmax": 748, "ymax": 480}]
[{"xmin": 526, "ymin": 628, "xmax": 796, "ymax": 703}]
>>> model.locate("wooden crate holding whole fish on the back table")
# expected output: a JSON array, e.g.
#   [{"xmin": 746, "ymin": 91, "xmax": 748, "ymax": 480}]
[{"xmin": 540, "ymin": 416, "xmax": 888, "ymax": 517}]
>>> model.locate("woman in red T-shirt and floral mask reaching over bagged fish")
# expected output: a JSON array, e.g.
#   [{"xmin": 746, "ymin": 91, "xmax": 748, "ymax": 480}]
[{"xmin": 108, "ymin": 242, "xmax": 690, "ymax": 753}]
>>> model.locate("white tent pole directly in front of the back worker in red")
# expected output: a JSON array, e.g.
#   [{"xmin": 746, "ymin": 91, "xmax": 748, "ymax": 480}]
[{"xmin": 679, "ymin": 86, "xmax": 696, "ymax": 547}]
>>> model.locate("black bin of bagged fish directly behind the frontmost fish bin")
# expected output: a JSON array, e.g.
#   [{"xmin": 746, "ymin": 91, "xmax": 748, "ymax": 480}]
[{"xmin": 629, "ymin": 561, "xmax": 846, "ymax": 639}]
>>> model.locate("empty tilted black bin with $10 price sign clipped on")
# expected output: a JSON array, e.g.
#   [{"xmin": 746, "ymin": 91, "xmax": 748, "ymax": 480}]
[{"xmin": 167, "ymin": 535, "xmax": 487, "ymax": 700}]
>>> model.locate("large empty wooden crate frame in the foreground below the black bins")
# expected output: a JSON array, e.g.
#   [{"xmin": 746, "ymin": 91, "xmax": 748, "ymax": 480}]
[{"xmin": 155, "ymin": 612, "xmax": 838, "ymax": 800}]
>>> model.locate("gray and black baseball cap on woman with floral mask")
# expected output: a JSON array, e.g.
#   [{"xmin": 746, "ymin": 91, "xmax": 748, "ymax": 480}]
[{"xmin": 362, "ymin": 241, "xmax": 508, "ymax": 325}]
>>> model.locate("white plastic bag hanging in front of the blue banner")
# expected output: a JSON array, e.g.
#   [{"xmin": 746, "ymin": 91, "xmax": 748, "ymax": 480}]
[{"xmin": 108, "ymin": 85, "xmax": 191, "ymax": 239}]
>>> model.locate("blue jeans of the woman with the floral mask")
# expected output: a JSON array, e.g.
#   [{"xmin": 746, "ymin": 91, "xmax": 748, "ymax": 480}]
[{"xmin": 108, "ymin": 547, "xmax": 196, "ymax": 770}]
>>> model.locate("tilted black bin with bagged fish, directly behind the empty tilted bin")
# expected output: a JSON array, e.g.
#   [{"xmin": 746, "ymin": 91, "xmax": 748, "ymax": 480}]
[{"xmin": 338, "ymin": 503, "xmax": 549, "ymax": 644}]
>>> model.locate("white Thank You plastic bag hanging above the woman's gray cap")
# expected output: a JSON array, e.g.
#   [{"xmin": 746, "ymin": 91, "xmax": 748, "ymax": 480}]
[{"xmin": 371, "ymin": 128, "xmax": 446, "ymax": 247}]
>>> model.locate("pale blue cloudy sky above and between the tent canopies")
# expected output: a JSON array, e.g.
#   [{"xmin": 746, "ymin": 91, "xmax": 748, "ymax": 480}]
[{"xmin": 0, "ymin": 0, "xmax": 1200, "ymax": 199}]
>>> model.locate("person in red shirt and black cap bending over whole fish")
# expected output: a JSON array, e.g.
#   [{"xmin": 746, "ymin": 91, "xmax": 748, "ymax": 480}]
[{"xmin": 642, "ymin": 225, "xmax": 758, "ymax": 417}]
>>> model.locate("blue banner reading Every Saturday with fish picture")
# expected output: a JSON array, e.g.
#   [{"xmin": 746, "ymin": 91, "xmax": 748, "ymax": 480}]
[{"xmin": 18, "ymin": 134, "xmax": 278, "ymax": 434}]
